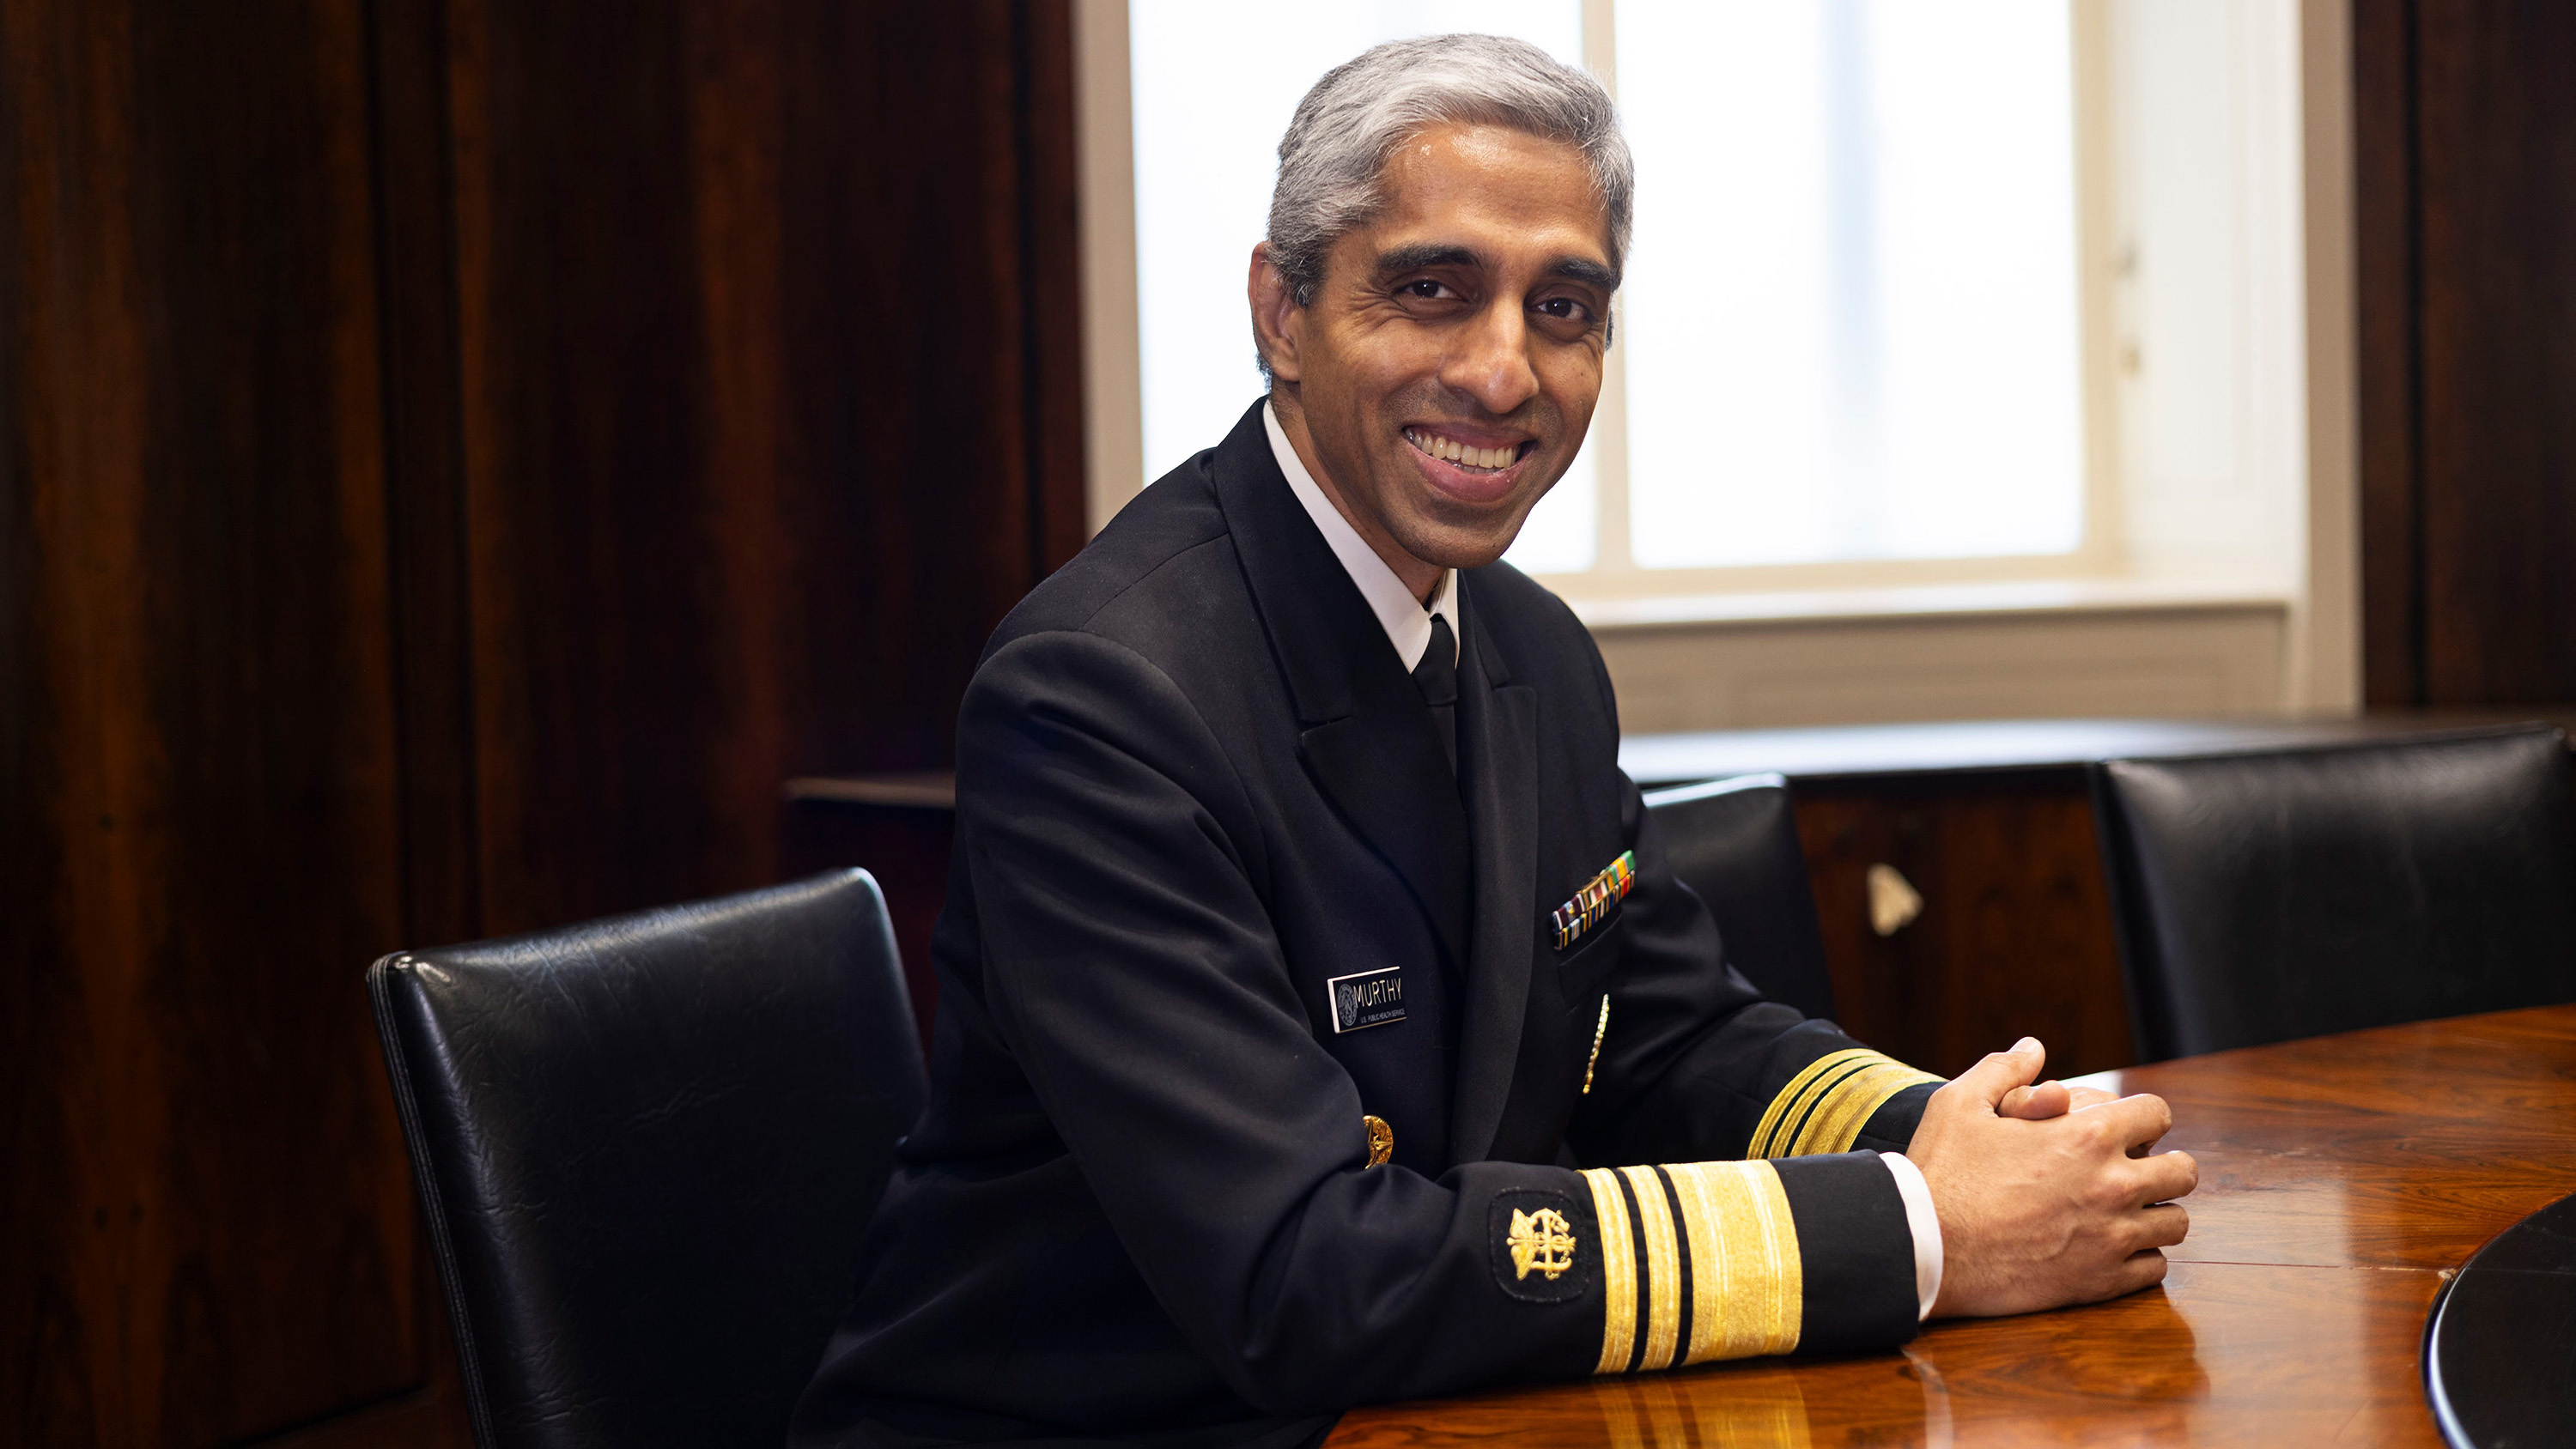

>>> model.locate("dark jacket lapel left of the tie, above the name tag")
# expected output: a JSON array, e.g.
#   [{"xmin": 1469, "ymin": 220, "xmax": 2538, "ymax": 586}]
[{"xmin": 1211, "ymin": 404, "xmax": 1468, "ymax": 983}]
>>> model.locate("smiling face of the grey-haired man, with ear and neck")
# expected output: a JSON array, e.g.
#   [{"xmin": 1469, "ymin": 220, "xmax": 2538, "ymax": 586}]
[{"xmin": 1252, "ymin": 126, "xmax": 1615, "ymax": 597}]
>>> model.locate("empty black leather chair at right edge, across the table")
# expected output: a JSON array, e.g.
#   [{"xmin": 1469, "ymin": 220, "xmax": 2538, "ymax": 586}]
[{"xmin": 2094, "ymin": 725, "xmax": 2576, "ymax": 1060}]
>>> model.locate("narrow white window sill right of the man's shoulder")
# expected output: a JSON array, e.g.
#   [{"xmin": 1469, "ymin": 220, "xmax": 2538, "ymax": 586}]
[{"xmin": 1540, "ymin": 579, "xmax": 2290, "ymax": 634}]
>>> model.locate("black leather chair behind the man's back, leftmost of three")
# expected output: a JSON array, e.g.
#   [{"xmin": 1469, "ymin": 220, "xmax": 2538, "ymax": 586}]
[{"xmin": 366, "ymin": 870, "xmax": 927, "ymax": 1449}]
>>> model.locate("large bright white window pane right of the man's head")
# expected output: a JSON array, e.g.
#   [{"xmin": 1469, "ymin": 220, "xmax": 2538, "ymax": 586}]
[{"xmin": 1618, "ymin": 0, "xmax": 2084, "ymax": 569}]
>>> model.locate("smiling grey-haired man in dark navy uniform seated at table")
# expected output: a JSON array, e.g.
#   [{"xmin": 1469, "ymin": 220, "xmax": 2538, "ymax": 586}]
[{"xmin": 796, "ymin": 36, "xmax": 2195, "ymax": 1446}]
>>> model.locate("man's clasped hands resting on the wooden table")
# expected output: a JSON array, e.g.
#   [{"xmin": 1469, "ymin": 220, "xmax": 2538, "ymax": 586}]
[{"xmin": 1906, "ymin": 1037, "xmax": 2200, "ymax": 1318}]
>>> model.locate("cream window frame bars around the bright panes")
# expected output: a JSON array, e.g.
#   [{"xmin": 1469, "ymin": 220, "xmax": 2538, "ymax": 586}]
[{"xmin": 1072, "ymin": 0, "xmax": 2357, "ymax": 703}]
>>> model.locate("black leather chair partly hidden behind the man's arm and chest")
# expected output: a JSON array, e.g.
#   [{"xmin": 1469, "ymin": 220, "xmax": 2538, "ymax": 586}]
[{"xmin": 1646, "ymin": 774, "xmax": 1834, "ymax": 1016}]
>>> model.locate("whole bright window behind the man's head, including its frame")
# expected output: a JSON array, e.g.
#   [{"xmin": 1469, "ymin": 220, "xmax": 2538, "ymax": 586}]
[{"xmin": 1087, "ymin": 0, "xmax": 2303, "ymax": 608}]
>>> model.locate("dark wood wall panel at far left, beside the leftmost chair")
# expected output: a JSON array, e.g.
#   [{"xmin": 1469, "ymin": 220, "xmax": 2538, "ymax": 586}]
[{"xmin": 0, "ymin": 3, "xmax": 420, "ymax": 1444}]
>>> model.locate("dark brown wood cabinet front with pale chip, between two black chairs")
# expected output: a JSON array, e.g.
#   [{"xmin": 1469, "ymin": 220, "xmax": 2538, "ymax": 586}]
[{"xmin": 1795, "ymin": 772, "xmax": 2136, "ymax": 1076}]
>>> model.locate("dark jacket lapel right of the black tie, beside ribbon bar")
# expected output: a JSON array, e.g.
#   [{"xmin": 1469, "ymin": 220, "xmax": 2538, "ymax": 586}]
[{"xmin": 1435, "ymin": 574, "xmax": 1538, "ymax": 1163}]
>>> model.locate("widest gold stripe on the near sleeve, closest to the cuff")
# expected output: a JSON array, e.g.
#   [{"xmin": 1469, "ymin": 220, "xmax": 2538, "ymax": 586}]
[{"xmin": 1664, "ymin": 1161, "xmax": 1806, "ymax": 1364}]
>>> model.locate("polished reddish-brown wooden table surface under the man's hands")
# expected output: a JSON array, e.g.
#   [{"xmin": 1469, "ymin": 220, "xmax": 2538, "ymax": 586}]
[{"xmin": 1329, "ymin": 1006, "xmax": 2576, "ymax": 1449}]
